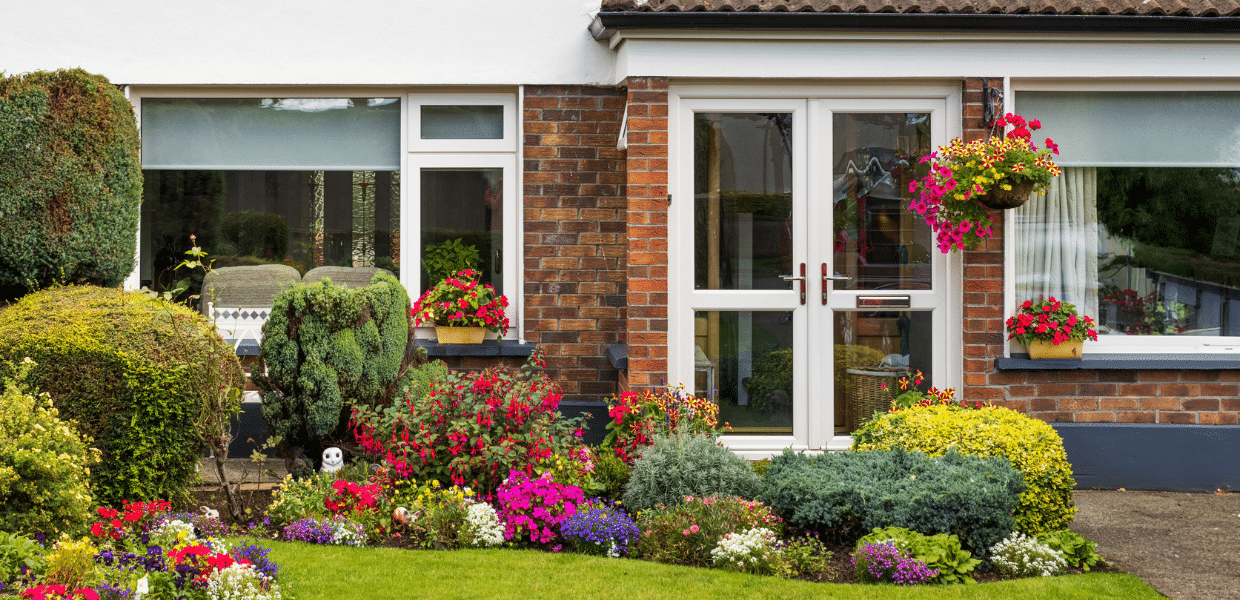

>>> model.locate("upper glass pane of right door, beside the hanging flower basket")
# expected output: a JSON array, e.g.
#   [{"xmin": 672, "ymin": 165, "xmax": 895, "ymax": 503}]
[{"xmin": 832, "ymin": 113, "xmax": 935, "ymax": 290}]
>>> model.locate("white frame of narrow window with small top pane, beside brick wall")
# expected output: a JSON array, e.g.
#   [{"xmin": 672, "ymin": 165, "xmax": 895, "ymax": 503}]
[{"xmin": 401, "ymin": 88, "xmax": 525, "ymax": 341}]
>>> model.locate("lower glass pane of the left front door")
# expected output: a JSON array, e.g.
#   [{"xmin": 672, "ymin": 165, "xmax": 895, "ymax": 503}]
[{"xmin": 693, "ymin": 311, "xmax": 792, "ymax": 435}]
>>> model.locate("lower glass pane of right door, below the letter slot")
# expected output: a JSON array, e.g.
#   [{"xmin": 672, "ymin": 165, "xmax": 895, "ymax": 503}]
[{"xmin": 835, "ymin": 311, "xmax": 934, "ymax": 435}]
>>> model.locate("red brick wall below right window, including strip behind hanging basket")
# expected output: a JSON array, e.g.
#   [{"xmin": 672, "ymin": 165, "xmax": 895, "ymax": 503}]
[{"xmin": 962, "ymin": 78, "xmax": 1240, "ymax": 425}]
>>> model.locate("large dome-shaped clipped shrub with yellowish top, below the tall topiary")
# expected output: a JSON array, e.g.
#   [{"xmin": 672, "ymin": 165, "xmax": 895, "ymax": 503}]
[{"xmin": 0, "ymin": 286, "xmax": 244, "ymax": 505}]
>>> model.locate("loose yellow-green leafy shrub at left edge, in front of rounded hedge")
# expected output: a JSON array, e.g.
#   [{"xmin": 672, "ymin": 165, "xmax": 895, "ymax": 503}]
[{"xmin": 0, "ymin": 363, "xmax": 99, "ymax": 535}]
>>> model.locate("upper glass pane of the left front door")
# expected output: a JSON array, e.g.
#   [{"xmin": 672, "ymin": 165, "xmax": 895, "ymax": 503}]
[{"xmin": 693, "ymin": 113, "xmax": 792, "ymax": 290}]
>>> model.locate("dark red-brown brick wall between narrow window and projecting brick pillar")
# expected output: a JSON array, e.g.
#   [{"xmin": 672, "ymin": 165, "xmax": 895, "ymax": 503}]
[{"xmin": 522, "ymin": 86, "xmax": 626, "ymax": 400}]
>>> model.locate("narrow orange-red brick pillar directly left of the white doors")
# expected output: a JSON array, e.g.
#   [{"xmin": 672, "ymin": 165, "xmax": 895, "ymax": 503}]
[{"xmin": 625, "ymin": 77, "xmax": 667, "ymax": 388}]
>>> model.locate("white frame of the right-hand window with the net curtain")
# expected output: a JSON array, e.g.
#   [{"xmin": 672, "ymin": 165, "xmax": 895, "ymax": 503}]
[{"xmin": 1003, "ymin": 77, "xmax": 1240, "ymax": 357}]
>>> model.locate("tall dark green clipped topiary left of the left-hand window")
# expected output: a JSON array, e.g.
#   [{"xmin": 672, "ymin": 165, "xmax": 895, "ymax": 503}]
[{"xmin": 0, "ymin": 69, "xmax": 143, "ymax": 301}]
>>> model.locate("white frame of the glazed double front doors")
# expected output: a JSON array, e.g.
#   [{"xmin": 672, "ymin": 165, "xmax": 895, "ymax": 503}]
[{"xmin": 667, "ymin": 82, "xmax": 963, "ymax": 460}]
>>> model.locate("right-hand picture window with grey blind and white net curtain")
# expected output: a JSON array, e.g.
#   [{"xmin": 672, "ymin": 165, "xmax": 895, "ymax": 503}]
[{"xmin": 1011, "ymin": 92, "xmax": 1240, "ymax": 352}]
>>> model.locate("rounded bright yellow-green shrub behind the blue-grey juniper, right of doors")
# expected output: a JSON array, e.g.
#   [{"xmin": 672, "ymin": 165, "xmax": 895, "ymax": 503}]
[{"xmin": 852, "ymin": 405, "xmax": 1076, "ymax": 536}]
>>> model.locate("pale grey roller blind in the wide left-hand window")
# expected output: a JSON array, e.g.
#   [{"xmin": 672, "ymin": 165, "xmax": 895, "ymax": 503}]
[{"xmin": 141, "ymin": 98, "xmax": 401, "ymax": 171}]
